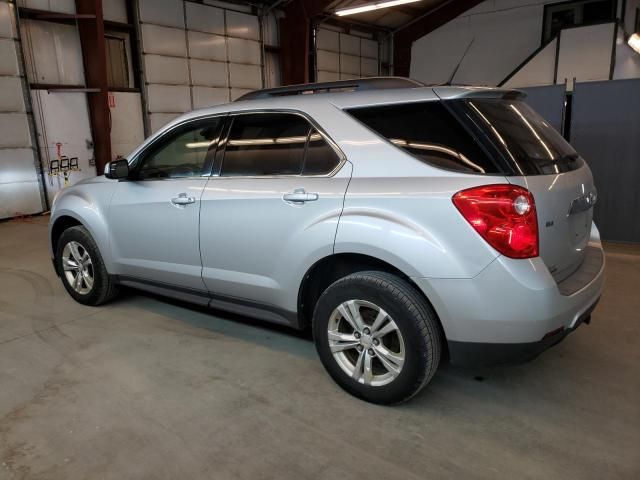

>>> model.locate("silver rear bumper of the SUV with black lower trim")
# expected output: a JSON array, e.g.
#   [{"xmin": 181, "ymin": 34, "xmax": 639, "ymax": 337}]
[{"xmin": 413, "ymin": 242, "xmax": 605, "ymax": 365}]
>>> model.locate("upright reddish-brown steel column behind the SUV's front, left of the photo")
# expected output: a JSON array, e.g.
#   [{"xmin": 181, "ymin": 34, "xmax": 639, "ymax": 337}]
[{"xmin": 76, "ymin": 0, "xmax": 111, "ymax": 175}]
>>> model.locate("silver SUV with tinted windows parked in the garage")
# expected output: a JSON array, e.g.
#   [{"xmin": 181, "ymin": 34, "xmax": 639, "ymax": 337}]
[{"xmin": 50, "ymin": 78, "xmax": 604, "ymax": 404}]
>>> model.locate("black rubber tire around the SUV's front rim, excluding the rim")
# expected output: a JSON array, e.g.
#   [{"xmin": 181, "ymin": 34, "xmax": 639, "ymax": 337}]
[{"xmin": 56, "ymin": 226, "xmax": 118, "ymax": 306}]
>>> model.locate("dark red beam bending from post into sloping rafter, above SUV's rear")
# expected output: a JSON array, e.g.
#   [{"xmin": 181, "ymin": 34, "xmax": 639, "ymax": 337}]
[{"xmin": 393, "ymin": 0, "xmax": 483, "ymax": 77}]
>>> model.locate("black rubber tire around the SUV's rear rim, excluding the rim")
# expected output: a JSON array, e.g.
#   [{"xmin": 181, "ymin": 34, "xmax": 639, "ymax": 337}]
[{"xmin": 313, "ymin": 271, "xmax": 442, "ymax": 405}]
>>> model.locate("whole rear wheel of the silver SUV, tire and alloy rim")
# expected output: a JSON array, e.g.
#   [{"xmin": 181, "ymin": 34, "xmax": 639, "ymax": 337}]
[{"xmin": 313, "ymin": 271, "xmax": 442, "ymax": 404}]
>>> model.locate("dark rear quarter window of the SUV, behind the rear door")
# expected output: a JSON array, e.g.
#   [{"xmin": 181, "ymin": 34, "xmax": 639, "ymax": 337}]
[{"xmin": 348, "ymin": 101, "xmax": 499, "ymax": 173}]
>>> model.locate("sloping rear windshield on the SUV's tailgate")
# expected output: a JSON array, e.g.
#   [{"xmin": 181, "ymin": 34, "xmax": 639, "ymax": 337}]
[{"xmin": 466, "ymin": 99, "xmax": 583, "ymax": 175}]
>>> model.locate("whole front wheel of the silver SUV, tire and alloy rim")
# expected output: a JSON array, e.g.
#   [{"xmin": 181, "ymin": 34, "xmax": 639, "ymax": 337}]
[{"xmin": 56, "ymin": 226, "xmax": 117, "ymax": 305}]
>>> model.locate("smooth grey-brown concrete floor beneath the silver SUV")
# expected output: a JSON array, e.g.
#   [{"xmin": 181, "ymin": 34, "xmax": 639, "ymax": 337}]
[{"xmin": 0, "ymin": 218, "xmax": 640, "ymax": 480}]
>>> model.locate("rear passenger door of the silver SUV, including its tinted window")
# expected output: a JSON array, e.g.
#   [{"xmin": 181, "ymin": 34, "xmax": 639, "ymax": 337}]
[{"xmin": 200, "ymin": 112, "xmax": 351, "ymax": 322}]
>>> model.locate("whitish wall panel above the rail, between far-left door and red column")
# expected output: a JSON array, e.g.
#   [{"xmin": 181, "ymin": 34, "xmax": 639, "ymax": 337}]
[{"xmin": 21, "ymin": 20, "xmax": 84, "ymax": 85}]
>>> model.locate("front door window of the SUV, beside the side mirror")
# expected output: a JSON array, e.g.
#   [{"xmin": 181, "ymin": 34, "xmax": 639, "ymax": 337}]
[{"xmin": 138, "ymin": 118, "xmax": 222, "ymax": 180}]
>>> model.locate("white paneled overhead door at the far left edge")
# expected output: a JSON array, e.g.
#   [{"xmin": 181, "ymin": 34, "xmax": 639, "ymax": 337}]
[{"xmin": 0, "ymin": 1, "xmax": 44, "ymax": 219}]
